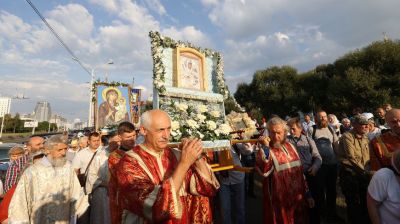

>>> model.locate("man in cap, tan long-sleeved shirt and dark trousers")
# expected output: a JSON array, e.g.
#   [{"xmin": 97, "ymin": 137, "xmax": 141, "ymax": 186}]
[{"xmin": 338, "ymin": 115, "xmax": 370, "ymax": 223}]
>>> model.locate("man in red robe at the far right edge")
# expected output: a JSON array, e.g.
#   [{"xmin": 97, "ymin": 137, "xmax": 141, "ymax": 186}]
[{"xmin": 370, "ymin": 108, "xmax": 400, "ymax": 171}]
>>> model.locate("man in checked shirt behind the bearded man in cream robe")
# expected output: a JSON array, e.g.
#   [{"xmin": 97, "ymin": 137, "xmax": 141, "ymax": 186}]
[{"xmin": 4, "ymin": 136, "xmax": 44, "ymax": 192}]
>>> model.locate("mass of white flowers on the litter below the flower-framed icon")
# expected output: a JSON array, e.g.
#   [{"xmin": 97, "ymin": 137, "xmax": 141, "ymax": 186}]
[{"xmin": 164, "ymin": 100, "xmax": 232, "ymax": 142}]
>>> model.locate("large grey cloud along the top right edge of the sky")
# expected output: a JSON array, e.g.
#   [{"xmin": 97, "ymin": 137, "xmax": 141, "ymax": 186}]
[{"xmin": 209, "ymin": 0, "xmax": 400, "ymax": 47}]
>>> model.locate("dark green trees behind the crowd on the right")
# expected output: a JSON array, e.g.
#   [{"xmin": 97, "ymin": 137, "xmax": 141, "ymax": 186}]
[{"xmin": 234, "ymin": 40, "xmax": 400, "ymax": 118}]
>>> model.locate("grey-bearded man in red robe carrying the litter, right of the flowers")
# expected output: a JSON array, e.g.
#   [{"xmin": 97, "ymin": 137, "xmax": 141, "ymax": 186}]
[{"xmin": 256, "ymin": 117, "xmax": 314, "ymax": 224}]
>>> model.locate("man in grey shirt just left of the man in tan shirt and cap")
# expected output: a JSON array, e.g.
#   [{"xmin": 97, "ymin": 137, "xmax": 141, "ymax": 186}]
[{"xmin": 307, "ymin": 111, "xmax": 343, "ymax": 222}]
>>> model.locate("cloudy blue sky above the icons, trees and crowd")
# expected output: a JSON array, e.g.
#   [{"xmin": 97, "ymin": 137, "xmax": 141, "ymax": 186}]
[{"xmin": 0, "ymin": 0, "xmax": 400, "ymax": 121}]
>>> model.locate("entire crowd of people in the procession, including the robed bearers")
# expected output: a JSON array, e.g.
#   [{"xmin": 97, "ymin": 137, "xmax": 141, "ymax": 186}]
[{"xmin": 0, "ymin": 107, "xmax": 400, "ymax": 224}]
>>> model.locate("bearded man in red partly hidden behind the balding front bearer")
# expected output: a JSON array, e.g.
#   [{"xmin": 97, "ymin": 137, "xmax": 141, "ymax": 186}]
[{"xmin": 108, "ymin": 122, "xmax": 136, "ymax": 224}]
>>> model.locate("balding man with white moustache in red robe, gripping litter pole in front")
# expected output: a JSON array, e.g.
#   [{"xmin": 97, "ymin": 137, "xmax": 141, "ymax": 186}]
[{"xmin": 116, "ymin": 110, "xmax": 219, "ymax": 223}]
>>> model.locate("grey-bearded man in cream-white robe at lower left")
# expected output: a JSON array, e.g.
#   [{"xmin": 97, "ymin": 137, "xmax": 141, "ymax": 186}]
[{"xmin": 9, "ymin": 135, "xmax": 81, "ymax": 223}]
